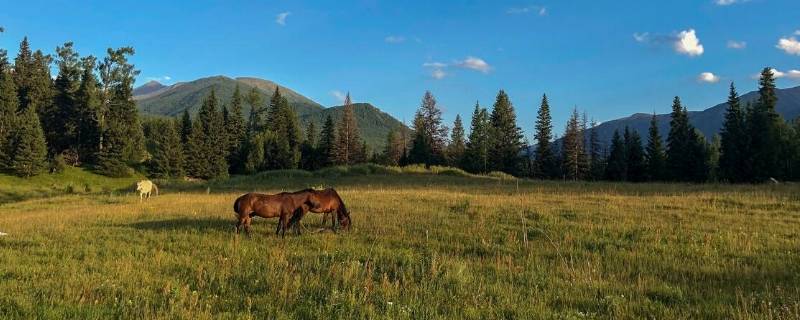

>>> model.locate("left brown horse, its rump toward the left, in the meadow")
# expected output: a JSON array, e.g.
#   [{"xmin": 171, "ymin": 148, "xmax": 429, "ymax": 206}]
[{"xmin": 233, "ymin": 189, "xmax": 319, "ymax": 237}]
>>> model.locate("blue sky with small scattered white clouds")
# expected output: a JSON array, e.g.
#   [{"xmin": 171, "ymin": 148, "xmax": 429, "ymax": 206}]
[{"xmin": 0, "ymin": 0, "xmax": 800, "ymax": 139}]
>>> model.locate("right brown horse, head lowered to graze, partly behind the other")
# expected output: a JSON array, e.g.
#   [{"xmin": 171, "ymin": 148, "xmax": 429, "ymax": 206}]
[{"xmin": 289, "ymin": 188, "xmax": 352, "ymax": 233}]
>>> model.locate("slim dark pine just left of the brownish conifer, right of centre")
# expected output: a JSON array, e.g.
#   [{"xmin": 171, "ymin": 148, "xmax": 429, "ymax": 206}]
[{"xmin": 534, "ymin": 95, "xmax": 558, "ymax": 179}]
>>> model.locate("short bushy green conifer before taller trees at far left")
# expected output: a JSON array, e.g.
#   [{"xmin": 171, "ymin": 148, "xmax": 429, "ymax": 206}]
[{"xmin": 6, "ymin": 108, "xmax": 47, "ymax": 177}]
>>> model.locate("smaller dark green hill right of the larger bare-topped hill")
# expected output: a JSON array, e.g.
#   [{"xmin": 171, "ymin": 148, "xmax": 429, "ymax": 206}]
[{"xmin": 300, "ymin": 103, "xmax": 403, "ymax": 151}]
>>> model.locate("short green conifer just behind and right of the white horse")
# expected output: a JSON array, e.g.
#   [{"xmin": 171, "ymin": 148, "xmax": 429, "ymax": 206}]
[{"xmin": 149, "ymin": 120, "xmax": 184, "ymax": 178}]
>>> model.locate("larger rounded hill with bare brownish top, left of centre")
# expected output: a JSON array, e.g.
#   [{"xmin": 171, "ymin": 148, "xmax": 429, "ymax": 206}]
[{"xmin": 134, "ymin": 76, "xmax": 322, "ymax": 116}]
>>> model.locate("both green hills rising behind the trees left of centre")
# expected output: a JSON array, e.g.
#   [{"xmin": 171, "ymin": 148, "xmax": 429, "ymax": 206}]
[{"xmin": 134, "ymin": 76, "xmax": 403, "ymax": 150}]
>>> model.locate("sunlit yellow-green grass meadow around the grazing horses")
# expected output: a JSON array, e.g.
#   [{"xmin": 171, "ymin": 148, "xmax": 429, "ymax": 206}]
[{"xmin": 0, "ymin": 168, "xmax": 800, "ymax": 319}]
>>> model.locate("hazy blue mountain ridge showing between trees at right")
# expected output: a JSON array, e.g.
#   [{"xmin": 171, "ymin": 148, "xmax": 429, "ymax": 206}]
[{"xmin": 597, "ymin": 86, "xmax": 800, "ymax": 144}]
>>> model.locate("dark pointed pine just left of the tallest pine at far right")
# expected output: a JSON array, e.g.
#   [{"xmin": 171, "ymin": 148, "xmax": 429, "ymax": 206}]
[{"xmin": 719, "ymin": 82, "xmax": 751, "ymax": 182}]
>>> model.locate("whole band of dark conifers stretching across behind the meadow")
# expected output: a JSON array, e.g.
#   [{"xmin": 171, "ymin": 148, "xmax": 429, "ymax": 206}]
[{"xmin": 0, "ymin": 38, "xmax": 800, "ymax": 183}]
